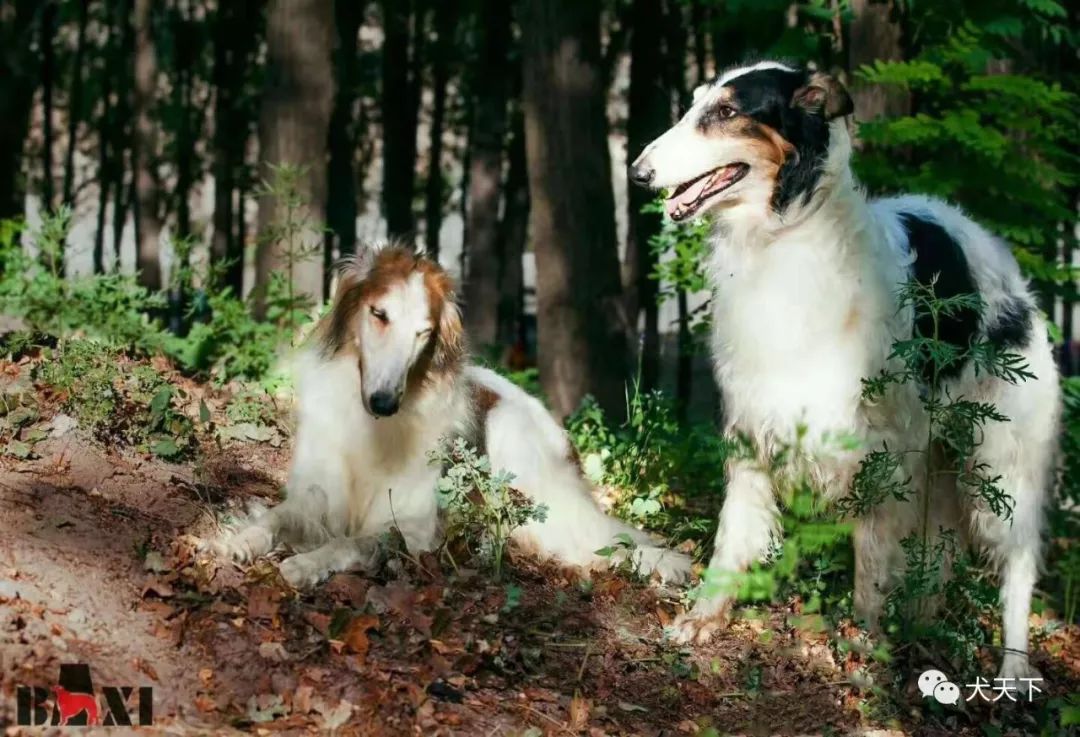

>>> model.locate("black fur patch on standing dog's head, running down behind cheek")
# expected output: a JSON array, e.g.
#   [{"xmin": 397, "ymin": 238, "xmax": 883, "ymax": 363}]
[{"xmin": 724, "ymin": 69, "xmax": 828, "ymax": 212}]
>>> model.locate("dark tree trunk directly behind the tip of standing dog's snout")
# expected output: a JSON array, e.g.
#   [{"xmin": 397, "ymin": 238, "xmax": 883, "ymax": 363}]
[{"xmin": 622, "ymin": 0, "xmax": 672, "ymax": 389}]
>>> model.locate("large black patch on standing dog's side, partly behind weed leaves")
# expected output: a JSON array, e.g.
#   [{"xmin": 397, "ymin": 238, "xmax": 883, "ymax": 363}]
[{"xmin": 900, "ymin": 213, "xmax": 978, "ymax": 384}]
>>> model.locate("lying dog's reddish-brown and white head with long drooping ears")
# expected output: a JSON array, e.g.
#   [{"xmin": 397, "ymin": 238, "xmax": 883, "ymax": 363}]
[{"xmin": 320, "ymin": 245, "xmax": 464, "ymax": 417}]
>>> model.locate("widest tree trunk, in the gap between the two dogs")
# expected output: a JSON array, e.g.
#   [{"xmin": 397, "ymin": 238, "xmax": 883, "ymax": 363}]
[{"xmin": 521, "ymin": 0, "xmax": 627, "ymax": 417}]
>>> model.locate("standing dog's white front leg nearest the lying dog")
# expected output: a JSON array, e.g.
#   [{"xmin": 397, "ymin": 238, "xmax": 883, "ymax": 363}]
[{"xmin": 672, "ymin": 460, "xmax": 777, "ymax": 644}]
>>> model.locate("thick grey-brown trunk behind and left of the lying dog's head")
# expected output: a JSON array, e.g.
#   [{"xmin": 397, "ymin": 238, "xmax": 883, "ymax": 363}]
[{"xmin": 255, "ymin": 0, "xmax": 334, "ymax": 318}]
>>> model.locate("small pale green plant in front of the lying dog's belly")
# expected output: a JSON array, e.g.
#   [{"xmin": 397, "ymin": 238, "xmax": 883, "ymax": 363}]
[{"xmin": 429, "ymin": 438, "xmax": 548, "ymax": 578}]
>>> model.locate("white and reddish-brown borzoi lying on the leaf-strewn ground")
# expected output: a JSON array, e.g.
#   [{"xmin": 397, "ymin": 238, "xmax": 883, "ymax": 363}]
[{"xmin": 212, "ymin": 246, "xmax": 690, "ymax": 588}]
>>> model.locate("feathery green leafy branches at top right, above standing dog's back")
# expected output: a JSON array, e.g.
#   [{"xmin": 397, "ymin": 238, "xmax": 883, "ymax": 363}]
[{"xmin": 856, "ymin": 0, "xmax": 1080, "ymax": 290}]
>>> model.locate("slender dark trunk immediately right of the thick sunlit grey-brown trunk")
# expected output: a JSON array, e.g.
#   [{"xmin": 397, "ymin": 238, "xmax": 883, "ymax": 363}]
[{"xmin": 324, "ymin": 0, "xmax": 365, "ymax": 290}]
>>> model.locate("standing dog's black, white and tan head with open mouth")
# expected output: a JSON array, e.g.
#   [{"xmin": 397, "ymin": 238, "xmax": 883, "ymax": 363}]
[{"xmin": 630, "ymin": 62, "xmax": 853, "ymax": 220}]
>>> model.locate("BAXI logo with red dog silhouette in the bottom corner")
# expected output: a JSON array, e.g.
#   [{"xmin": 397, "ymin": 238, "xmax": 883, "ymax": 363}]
[{"xmin": 15, "ymin": 664, "xmax": 153, "ymax": 726}]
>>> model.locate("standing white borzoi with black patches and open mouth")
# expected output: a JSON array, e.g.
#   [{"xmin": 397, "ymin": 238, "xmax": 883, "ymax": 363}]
[{"xmin": 630, "ymin": 62, "xmax": 1059, "ymax": 679}]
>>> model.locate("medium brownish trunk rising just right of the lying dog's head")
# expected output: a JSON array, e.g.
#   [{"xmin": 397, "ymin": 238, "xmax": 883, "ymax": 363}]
[{"xmin": 464, "ymin": 0, "xmax": 511, "ymax": 348}]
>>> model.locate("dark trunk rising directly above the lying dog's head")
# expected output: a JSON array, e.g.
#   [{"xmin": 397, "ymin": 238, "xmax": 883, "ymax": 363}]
[{"xmin": 381, "ymin": 0, "xmax": 423, "ymax": 238}]
